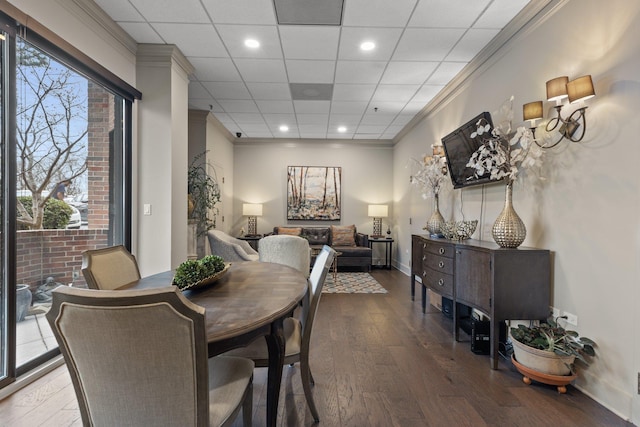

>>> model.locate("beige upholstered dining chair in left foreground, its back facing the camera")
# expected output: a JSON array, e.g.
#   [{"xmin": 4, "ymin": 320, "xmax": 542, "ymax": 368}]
[{"xmin": 47, "ymin": 286, "xmax": 254, "ymax": 427}]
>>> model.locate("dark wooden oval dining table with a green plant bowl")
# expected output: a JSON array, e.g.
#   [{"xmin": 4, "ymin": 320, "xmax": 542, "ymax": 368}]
[{"xmin": 120, "ymin": 261, "xmax": 308, "ymax": 426}]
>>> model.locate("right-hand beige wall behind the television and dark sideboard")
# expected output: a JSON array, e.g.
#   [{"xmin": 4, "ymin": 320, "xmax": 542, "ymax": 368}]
[{"xmin": 394, "ymin": 0, "xmax": 640, "ymax": 424}]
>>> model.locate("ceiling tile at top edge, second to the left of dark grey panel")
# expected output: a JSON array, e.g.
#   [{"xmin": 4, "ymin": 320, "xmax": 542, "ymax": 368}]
[{"xmin": 124, "ymin": 0, "xmax": 209, "ymax": 23}]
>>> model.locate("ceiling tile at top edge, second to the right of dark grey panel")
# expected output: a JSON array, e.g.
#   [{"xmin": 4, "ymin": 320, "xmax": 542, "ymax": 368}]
[{"xmin": 409, "ymin": 0, "xmax": 489, "ymax": 28}]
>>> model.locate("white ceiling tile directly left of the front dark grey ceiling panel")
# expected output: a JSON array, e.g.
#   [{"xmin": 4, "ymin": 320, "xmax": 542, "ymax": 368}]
[{"xmin": 202, "ymin": 0, "xmax": 277, "ymax": 25}]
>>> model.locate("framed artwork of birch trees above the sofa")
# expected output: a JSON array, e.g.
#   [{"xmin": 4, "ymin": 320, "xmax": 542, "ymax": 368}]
[{"xmin": 287, "ymin": 166, "xmax": 342, "ymax": 221}]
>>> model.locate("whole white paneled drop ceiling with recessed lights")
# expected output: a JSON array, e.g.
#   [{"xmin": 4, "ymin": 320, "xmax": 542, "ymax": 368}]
[{"xmin": 95, "ymin": 0, "xmax": 529, "ymax": 139}]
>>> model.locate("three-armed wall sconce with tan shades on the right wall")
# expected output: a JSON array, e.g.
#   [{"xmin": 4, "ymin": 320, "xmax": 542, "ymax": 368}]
[{"xmin": 522, "ymin": 75, "xmax": 596, "ymax": 148}]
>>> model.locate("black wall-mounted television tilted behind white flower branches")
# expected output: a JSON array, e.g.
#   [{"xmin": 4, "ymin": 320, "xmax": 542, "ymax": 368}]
[{"xmin": 442, "ymin": 111, "xmax": 498, "ymax": 188}]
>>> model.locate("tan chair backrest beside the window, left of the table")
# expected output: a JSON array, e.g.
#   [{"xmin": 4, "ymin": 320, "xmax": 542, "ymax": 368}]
[{"xmin": 82, "ymin": 245, "xmax": 140, "ymax": 290}]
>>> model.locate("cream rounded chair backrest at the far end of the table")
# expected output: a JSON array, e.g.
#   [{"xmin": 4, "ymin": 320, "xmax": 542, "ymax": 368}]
[{"xmin": 258, "ymin": 234, "xmax": 311, "ymax": 277}]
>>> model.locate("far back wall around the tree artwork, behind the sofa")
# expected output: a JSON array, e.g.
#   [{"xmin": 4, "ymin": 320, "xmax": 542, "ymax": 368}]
[{"xmin": 231, "ymin": 140, "xmax": 393, "ymax": 241}]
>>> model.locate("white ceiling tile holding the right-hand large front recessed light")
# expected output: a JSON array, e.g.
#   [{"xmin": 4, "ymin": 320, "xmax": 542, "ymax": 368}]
[{"xmin": 338, "ymin": 27, "xmax": 402, "ymax": 61}]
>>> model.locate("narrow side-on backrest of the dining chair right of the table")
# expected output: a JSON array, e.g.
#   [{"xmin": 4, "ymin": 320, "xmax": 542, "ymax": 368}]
[{"xmin": 300, "ymin": 245, "xmax": 336, "ymax": 353}]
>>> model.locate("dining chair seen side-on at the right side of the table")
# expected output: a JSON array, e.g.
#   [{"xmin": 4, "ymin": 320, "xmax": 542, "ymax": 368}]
[{"xmin": 225, "ymin": 245, "xmax": 336, "ymax": 422}]
